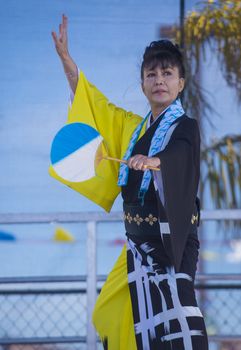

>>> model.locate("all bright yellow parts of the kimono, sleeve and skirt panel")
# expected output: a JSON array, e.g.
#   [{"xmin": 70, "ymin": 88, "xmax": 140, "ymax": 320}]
[{"xmin": 49, "ymin": 72, "xmax": 146, "ymax": 350}]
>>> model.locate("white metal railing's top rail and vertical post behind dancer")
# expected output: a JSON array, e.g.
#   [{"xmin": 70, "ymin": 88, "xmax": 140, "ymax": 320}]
[{"xmin": 0, "ymin": 209, "xmax": 241, "ymax": 350}]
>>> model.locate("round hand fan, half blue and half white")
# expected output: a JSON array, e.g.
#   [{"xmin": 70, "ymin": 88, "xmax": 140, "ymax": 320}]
[{"xmin": 50, "ymin": 123, "xmax": 103, "ymax": 182}]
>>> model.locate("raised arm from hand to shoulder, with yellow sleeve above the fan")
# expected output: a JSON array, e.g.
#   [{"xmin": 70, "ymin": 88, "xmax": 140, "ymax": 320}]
[{"xmin": 52, "ymin": 15, "xmax": 142, "ymax": 158}]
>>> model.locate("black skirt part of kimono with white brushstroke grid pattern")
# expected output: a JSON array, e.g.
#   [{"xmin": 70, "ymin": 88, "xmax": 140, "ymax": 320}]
[{"xmin": 127, "ymin": 233, "xmax": 208, "ymax": 350}]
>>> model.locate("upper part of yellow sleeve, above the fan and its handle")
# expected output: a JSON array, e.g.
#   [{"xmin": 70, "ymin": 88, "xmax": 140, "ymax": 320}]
[{"xmin": 68, "ymin": 72, "xmax": 142, "ymax": 158}]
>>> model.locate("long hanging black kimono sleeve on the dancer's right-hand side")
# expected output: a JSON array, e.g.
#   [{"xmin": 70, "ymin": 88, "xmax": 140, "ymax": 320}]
[{"xmin": 155, "ymin": 117, "xmax": 200, "ymax": 272}]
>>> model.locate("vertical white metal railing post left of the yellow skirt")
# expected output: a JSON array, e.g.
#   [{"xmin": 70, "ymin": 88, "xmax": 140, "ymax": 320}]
[{"xmin": 87, "ymin": 221, "xmax": 96, "ymax": 350}]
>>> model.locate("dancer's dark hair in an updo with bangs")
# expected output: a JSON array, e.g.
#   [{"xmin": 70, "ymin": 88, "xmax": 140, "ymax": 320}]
[{"xmin": 141, "ymin": 40, "xmax": 185, "ymax": 80}]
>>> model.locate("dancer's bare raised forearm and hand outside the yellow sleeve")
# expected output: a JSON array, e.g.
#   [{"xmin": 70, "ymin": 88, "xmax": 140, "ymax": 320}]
[{"xmin": 52, "ymin": 15, "xmax": 78, "ymax": 94}]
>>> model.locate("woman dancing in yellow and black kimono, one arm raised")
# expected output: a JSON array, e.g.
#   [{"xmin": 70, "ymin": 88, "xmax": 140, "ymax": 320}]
[{"xmin": 52, "ymin": 16, "xmax": 208, "ymax": 350}]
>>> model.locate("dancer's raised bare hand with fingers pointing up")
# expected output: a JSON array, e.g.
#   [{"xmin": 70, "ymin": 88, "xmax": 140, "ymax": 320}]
[{"xmin": 51, "ymin": 15, "xmax": 69, "ymax": 59}]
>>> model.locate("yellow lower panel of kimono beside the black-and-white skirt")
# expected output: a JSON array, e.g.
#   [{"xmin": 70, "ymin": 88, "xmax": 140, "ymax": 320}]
[{"xmin": 93, "ymin": 246, "xmax": 136, "ymax": 350}]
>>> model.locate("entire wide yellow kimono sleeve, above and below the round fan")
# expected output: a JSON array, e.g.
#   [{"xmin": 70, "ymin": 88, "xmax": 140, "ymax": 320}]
[{"xmin": 49, "ymin": 72, "xmax": 142, "ymax": 211}]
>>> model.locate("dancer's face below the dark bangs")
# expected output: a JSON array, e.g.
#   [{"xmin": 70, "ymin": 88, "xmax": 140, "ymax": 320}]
[{"xmin": 142, "ymin": 66, "xmax": 184, "ymax": 112}]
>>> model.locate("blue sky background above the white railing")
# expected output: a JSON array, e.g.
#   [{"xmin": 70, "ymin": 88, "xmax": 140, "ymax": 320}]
[{"xmin": 0, "ymin": 0, "xmax": 240, "ymax": 212}]
